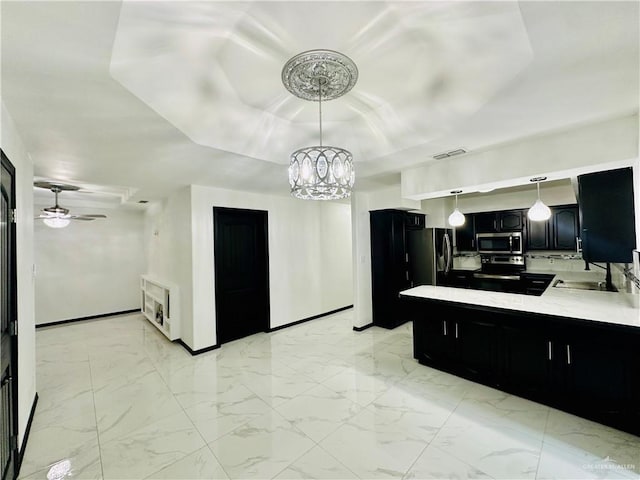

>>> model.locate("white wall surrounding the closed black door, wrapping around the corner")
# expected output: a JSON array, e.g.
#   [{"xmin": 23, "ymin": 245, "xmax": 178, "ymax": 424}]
[{"xmin": 147, "ymin": 185, "xmax": 353, "ymax": 350}]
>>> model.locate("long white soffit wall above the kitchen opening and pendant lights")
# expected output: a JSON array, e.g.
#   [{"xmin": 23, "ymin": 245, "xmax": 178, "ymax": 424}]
[{"xmin": 401, "ymin": 114, "xmax": 639, "ymax": 199}]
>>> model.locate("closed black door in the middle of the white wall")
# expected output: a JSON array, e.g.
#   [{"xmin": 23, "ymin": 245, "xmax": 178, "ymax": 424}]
[{"xmin": 213, "ymin": 207, "xmax": 269, "ymax": 343}]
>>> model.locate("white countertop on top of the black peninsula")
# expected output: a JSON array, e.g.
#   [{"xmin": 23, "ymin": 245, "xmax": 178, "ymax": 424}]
[{"xmin": 400, "ymin": 270, "xmax": 640, "ymax": 328}]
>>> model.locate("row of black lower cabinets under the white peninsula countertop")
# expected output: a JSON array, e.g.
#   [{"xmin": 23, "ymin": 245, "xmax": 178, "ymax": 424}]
[{"xmin": 402, "ymin": 296, "xmax": 640, "ymax": 435}]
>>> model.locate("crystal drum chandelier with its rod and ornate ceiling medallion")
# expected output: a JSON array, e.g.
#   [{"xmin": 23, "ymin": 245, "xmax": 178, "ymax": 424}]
[{"xmin": 282, "ymin": 50, "xmax": 358, "ymax": 200}]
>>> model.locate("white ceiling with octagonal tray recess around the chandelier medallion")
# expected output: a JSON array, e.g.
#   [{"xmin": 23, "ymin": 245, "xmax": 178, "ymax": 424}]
[{"xmin": 0, "ymin": 0, "xmax": 640, "ymax": 208}]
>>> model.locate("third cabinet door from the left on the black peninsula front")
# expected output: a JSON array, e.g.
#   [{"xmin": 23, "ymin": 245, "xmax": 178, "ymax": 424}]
[{"xmin": 503, "ymin": 325, "xmax": 553, "ymax": 399}]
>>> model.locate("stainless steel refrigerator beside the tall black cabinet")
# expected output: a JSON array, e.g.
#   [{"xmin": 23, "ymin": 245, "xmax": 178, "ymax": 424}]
[{"xmin": 407, "ymin": 228, "xmax": 453, "ymax": 287}]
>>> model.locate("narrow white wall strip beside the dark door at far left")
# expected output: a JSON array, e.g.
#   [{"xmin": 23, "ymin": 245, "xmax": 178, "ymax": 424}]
[{"xmin": 0, "ymin": 103, "xmax": 36, "ymax": 445}]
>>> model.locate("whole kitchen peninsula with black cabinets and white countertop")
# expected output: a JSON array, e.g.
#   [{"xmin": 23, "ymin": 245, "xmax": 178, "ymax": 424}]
[{"xmin": 400, "ymin": 272, "xmax": 640, "ymax": 435}]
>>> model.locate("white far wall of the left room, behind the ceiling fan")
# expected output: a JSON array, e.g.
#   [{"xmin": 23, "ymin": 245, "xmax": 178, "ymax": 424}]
[{"xmin": 34, "ymin": 204, "xmax": 146, "ymax": 325}]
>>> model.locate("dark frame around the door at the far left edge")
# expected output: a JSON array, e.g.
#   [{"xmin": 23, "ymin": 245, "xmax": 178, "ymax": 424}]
[{"xmin": 0, "ymin": 148, "xmax": 20, "ymax": 478}]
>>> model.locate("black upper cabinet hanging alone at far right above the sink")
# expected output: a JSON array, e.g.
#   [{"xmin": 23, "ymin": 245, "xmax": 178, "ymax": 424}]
[{"xmin": 578, "ymin": 167, "xmax": 636, "ymax": 263}]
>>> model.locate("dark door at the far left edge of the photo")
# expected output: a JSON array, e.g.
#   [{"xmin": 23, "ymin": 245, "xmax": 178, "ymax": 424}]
[{"xmin": 0, "ymin": 151, "xmax": 18, "ymax": 480}]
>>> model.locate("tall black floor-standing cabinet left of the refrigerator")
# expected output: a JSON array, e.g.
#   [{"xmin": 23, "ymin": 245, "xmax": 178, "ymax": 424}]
[{"xmin": 370, "ymin": 210, "xmax": 425, "ymax": 328}]
